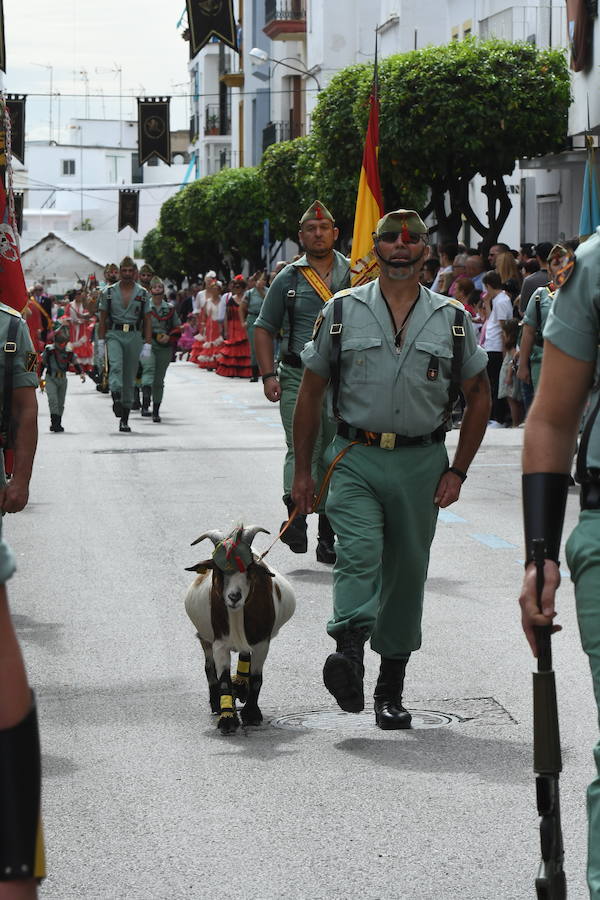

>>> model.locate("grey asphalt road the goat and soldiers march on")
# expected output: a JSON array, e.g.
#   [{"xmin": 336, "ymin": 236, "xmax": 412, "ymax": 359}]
[{"xmin": 4, "ymin": 363, "xmax": 597, "ymax": 900}]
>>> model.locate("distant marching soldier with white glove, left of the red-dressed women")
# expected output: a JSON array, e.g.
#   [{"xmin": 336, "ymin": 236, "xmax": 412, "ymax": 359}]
[{"xmin": 98, "ymin": 256, "xmax": 152, "ymax": 432}]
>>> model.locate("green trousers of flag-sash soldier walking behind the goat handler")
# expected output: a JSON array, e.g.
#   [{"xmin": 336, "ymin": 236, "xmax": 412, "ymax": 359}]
[{"xmin": 279, "ymin": 363, "xmax": 336, "ymax": 512}]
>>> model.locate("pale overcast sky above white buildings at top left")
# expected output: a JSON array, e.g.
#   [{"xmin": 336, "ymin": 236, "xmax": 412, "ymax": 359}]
[{"xmin": 4, "ymin": 0, "xmax": 189, "ymax": 140}]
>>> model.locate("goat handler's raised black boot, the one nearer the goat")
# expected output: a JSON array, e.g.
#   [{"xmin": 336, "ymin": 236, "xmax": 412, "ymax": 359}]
[{"xmin": 323, "ymin": 628, "xmax": 368, "ymax": 712}]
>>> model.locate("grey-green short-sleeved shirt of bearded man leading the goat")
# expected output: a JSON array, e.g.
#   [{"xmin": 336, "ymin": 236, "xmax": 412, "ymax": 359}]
[{"xmin": 302, "ymin": 279, "xmax": 487, "ymax": 437}]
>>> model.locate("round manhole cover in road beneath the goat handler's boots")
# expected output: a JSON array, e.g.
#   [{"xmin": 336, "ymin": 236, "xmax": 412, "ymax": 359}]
[{"xmin": 271, "ymin": 697, "xmax": 516, "ymax": 733}]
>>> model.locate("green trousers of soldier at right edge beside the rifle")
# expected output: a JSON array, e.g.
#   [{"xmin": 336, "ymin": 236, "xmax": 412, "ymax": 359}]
[{"xmin": 566, "ymin": 509, "xmax": 600, "ymax": 900}]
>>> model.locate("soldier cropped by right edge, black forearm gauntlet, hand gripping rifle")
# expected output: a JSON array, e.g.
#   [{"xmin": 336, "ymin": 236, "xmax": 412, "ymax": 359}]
[{"xmin": 520, "ymin": 229, "xmax": 600, "ymax": 900}]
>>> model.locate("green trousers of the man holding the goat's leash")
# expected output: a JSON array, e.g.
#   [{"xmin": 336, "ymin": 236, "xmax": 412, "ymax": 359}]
[{"xmin": 326, "ymin": 436, "xmax": 448, "ymax": 659}]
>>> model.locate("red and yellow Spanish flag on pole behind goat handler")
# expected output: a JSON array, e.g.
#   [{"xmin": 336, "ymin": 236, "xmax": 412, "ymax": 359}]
[{"xmin": 350, "ymin": 48, "xmax": 383, "ymax": 285}]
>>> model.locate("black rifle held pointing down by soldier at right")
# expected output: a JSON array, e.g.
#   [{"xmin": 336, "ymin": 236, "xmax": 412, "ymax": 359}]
[{"xmin": 532, "ymin": 538, "xmax": 567, "ymax": 900}]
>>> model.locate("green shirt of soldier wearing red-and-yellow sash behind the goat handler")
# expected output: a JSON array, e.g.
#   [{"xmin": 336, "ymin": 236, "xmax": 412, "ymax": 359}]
[{"xmin": 254, "ymin": 250, "xmax": 350, "ymax": 354}]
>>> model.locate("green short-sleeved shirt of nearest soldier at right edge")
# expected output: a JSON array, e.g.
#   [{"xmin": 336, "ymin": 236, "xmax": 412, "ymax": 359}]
[{"xmin": 544, "ymin": 228, "xmax": 600, "ymax": 468}]
